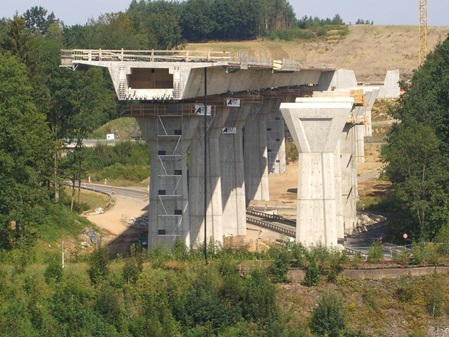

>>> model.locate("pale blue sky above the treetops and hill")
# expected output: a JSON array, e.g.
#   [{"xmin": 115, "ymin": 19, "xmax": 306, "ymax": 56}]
[{"xmin": 0, "ymin": 0, "xmax": 449, "ymax": 26}]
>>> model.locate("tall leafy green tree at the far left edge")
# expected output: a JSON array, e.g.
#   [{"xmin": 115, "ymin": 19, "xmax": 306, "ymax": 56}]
[{"xmin": 0, "ymin": 54, "xmax": 51, "ymax": 248}]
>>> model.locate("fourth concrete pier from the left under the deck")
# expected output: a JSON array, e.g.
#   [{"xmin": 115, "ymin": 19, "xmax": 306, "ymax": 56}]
[{"xmin": 243, "ymin": 100, "xmax": 274, "ymax": 205}]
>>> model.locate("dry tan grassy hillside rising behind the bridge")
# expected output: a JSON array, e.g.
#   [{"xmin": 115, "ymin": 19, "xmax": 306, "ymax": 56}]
[{"xmin": 186, "ymin": 25, "xmax": 449, "ymax": 83}]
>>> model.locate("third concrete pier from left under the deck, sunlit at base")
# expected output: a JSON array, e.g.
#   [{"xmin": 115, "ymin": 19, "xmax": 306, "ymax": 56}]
[{"xmin": 220, "ymin": 104, "xmax": 253, "ymax": 235}]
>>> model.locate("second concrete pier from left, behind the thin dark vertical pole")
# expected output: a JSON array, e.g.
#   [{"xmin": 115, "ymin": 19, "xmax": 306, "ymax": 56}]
[{"xmin": 189, "ymin": 107, "xmax": 230, "ymax": 244}]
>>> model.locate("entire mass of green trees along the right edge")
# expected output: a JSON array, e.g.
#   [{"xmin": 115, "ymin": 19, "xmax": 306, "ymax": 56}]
[{"xmin": 382, "ymin": 33, "xmax": 449, "ymax": 240}]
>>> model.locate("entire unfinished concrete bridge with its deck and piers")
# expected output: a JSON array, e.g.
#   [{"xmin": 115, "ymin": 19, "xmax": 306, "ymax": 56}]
[{"xmin": 61, "ymin": 49, "xmax": 399, "ymax": 248}]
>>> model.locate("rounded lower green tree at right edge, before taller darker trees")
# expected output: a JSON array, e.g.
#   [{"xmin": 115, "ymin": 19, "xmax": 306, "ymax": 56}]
[{"xmin": 382, "ymin": 124, "xmax": 449, "ymax": 239}]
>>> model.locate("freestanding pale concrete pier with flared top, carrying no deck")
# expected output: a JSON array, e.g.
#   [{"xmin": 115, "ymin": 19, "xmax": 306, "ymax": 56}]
[{"xmin": 281, "ymin": 97, "xmax": 354, "ymax": 247}]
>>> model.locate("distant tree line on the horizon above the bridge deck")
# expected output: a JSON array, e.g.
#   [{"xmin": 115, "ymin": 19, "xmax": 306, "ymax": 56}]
[{"xmin": 3, "ymin": 0, "xmax": 345, "ymax": 49}]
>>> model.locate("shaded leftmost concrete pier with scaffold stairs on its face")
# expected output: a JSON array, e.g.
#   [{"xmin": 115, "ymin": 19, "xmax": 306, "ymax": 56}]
[{"xmin": 136, "ymin": 111, "xmax": 200, "ymax": 248}]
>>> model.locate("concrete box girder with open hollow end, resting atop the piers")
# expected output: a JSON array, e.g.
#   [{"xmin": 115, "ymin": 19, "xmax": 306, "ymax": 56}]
[{"xmin": 94, "ymin": 57, "xmax": 322, "ymax": 100}]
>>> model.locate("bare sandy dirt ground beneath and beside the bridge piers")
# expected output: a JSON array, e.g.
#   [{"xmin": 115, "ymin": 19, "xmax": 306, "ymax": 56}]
[{"xmin": 88, "ymin": 144, "xmax": 385, "ymax": 256}]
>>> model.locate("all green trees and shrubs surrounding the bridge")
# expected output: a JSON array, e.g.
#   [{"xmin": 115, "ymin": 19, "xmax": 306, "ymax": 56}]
[{"xmin": 0, "ymin": 0, "xmax": 449, "ymax": 336}]
